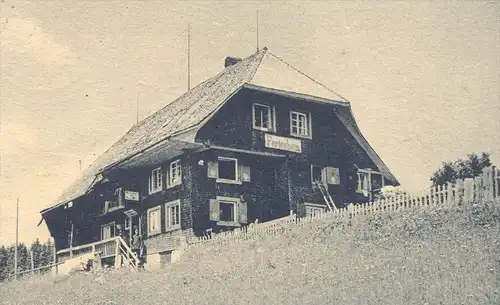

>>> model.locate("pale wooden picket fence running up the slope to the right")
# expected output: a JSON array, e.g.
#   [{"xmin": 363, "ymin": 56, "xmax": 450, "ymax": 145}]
[{"xmin": 186, "ymin": 167, "xmax": 500, "ymax": 249}]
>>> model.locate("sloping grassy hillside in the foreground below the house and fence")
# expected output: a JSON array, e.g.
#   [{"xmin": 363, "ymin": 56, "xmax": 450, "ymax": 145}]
[{"xmin": 0, "ymin": 203, "xmax": 500, "ymax": 305}]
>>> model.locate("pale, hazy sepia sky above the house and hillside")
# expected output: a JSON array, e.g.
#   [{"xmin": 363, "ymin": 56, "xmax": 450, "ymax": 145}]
[{"xmin": 0, "ymin": 0, "xmax": 500, "ymax": 244}]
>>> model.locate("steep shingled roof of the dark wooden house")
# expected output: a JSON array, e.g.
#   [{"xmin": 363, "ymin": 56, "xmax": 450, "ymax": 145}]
[{"xmin": 42, "ymin": 48, "xmax": 396, "ymax": 212}]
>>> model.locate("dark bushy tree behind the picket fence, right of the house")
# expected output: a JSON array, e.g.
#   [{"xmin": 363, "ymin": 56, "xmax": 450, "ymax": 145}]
[{"xmin": 430, "ymin": 152, "xmax": 491, "ymax": 186}]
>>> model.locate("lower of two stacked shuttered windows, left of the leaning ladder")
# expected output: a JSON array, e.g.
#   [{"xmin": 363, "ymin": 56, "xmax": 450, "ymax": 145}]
[{"xmin": 210, "ymin": 196, "xmax": 247, "ymax": 226}]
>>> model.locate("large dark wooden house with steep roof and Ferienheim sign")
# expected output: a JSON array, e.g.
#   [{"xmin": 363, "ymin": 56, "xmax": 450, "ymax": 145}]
[{"xmin": 41, "ymin": 48, "xmax": 398, "ymax": 266}]
